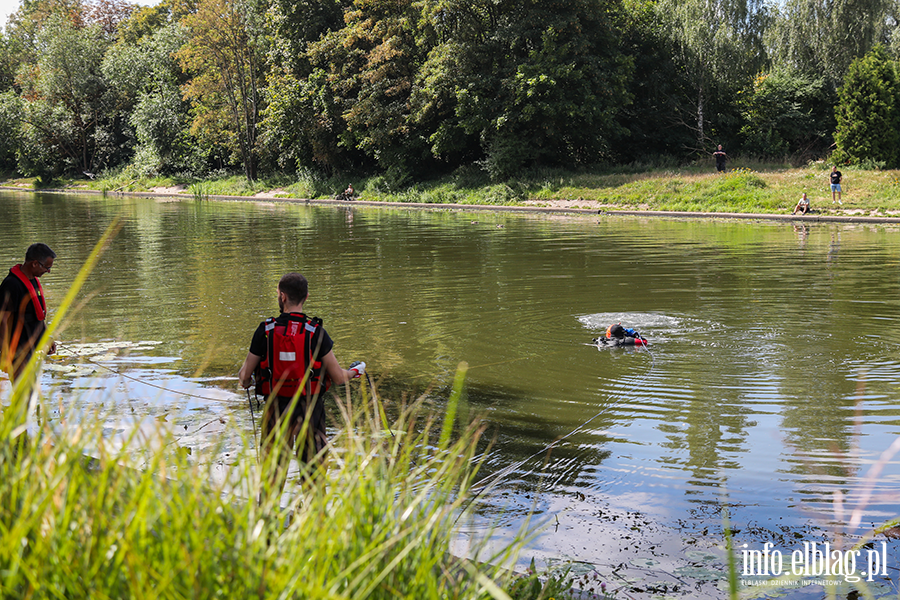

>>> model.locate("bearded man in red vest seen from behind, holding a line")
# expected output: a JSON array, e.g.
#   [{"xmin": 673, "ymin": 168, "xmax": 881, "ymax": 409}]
[{"xmin": 238, "ymin": 273, "xmax": 366, "ymax": 499}]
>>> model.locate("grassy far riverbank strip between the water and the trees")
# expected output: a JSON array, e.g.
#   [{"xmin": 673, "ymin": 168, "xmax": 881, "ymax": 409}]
[{"xmin": 2, "ymin": 161, "xmax": 900, "ymax": 216}]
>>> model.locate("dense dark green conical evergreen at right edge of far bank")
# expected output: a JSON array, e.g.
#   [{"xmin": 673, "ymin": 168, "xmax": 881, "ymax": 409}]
[{"xmin": 834, "ymin": 44, "xmax": 900, "ymax": 168}]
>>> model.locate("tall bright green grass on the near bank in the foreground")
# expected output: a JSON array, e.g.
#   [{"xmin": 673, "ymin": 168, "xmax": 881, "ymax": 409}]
[{"xmin": 0, "ymin": 225, "xmax": 536, "ymax": 600}]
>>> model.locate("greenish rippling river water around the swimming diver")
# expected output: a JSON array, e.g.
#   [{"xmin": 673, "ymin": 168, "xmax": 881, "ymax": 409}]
[{"xmin": 0, "ymin": 193, "xmax": 900, "ymax": 597}]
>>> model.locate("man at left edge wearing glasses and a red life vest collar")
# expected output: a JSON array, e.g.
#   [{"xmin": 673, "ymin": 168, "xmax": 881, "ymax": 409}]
[{"xmin": 0, "ymin": 243, "xmax": 56, "ymax": 380}]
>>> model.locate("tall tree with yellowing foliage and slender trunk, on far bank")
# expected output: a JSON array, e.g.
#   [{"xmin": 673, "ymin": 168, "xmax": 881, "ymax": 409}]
[{"xmin": 176, "ymin": 0, "xmax": 265, "ymax": 181}]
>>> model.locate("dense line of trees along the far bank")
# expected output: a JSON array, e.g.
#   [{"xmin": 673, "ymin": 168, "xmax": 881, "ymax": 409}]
[{"xmin": 0, "ymin": 0, "xmax": 900, "ymax": 185}]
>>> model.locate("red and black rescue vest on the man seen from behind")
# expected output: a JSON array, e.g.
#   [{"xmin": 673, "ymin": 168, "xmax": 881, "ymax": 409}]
[{"xmin": 256, "ymin": 313, "xmax": 328, "ymax": 398}]
